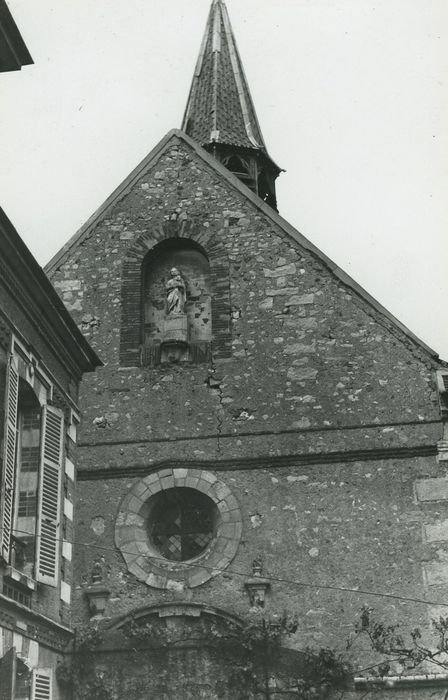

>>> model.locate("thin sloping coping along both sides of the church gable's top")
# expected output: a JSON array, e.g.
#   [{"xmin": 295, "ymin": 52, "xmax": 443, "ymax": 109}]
[{"xmin": 44, "ymin": 129, "xmax": 443, "ymax": 362}]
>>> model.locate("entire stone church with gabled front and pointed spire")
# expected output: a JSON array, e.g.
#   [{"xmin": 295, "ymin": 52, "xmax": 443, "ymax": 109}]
[{"xmin": 43, "ymin": 0, "xmax": 448, "ymax": 700}]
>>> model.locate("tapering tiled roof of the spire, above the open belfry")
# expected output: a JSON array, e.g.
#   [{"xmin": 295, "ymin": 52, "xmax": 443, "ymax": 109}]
[{"xmin": 182, "ymin": 0, "xmax": 266, "ymax": 151}]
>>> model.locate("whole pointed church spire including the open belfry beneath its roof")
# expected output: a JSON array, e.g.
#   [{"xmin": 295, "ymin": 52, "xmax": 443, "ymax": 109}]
[{"xmin": 182, "ymin": 0, "xmax": 280, "ymax": 208}]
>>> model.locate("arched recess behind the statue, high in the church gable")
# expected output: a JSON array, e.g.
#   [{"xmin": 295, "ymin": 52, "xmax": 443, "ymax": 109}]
[{"xmin": 142, "ymin": 238, "xmax": 212, "ymax": 365}]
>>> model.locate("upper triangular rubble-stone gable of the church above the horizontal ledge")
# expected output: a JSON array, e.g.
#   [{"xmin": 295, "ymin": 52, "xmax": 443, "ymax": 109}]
[{"xmin": 43, "ymin": 125, "xmax": 440, "ymax": 459}]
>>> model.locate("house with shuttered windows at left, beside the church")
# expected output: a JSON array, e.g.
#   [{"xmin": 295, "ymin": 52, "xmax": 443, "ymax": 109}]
[{"xmin": 0, "ymin": 209, "xmax": 100, "ymax": 700}]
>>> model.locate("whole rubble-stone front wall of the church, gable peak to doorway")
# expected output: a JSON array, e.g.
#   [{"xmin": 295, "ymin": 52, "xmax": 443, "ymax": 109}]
[{"xmin": 47, "ymin": 137, "xmax": 448, "ymax": 696}]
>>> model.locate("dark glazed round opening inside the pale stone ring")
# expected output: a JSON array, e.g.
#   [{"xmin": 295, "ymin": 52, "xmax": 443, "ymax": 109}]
[{"xmin": 148, "ymin": 488, "xmax": 219, "ymax": 561}]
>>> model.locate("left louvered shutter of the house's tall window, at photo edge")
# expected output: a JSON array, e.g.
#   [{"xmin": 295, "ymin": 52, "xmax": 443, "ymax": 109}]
[{"xmin": 0, "ymin": 355, "xmax": 19, "ymax": 563}]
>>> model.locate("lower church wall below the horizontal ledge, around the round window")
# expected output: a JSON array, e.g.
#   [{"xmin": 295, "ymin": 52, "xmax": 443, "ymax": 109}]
[{"xmin": 74, "ymin": 458, "xmax": 438, "ymax": 649}]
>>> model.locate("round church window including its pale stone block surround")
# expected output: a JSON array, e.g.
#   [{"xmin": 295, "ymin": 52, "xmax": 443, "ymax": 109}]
[{"xmin": 115, "ymin": 468, "xmax": 243, "ymax": 591}]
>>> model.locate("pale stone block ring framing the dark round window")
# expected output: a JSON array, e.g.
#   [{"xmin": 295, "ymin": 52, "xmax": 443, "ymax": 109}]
[{"xmin": 115, "ymin": 468, "xmax": 243, "ymax": 591}]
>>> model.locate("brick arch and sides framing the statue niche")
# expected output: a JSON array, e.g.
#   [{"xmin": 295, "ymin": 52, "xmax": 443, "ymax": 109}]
[{"xmin": 120, "ymin": 218, "xmax": 232, "ymax": 367}]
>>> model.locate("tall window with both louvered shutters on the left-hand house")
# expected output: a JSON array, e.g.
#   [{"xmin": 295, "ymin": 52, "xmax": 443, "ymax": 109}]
[{"xmin": 0, "ymin": 342, "xmax": 64, "ymax": 586}]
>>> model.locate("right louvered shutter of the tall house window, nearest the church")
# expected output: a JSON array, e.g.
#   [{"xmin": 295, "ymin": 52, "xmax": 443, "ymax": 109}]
[{"xmin": 36, "ymin": 406, "xmax": 64, "ymax": 586}]
